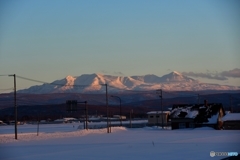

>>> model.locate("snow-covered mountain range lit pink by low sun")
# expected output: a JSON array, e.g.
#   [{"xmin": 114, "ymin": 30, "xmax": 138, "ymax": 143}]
[{"xmin": 18, "ymin": 71, "xmax": 239, "ymax": 94}]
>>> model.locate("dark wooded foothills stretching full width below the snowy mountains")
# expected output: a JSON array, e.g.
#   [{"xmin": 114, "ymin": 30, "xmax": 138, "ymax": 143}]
[{"xmin": 0, "ymin": 93, "xmax": 240, "ymax": 121}]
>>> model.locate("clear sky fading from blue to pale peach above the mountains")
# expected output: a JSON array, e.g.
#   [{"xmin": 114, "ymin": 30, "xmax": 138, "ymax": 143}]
[{"xmin": 0, "ymin": 0, "xmax": 240, "ymax": 93}]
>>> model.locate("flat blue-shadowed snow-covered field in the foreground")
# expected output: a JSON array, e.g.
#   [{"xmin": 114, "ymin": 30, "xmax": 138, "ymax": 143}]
[{"xmin": 0, "ymin": 123, "xmax": 240, "ymax": 160}]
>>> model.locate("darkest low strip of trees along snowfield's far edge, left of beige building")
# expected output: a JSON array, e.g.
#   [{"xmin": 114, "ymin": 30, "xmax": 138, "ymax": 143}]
[{"xmin": 0, "ymin": 104, "xmax": 153, "ymax": 122}]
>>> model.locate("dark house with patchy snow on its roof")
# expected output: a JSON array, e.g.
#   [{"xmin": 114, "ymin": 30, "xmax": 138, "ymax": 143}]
[{"xmin": 170, "ymin": 101, "xmax": 225, "ymax": 129}]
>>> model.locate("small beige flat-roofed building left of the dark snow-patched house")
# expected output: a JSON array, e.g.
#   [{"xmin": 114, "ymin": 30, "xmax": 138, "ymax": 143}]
[{"xmin": 147, "ymin": 111, "xmax": 170, "ymax": 126}]
